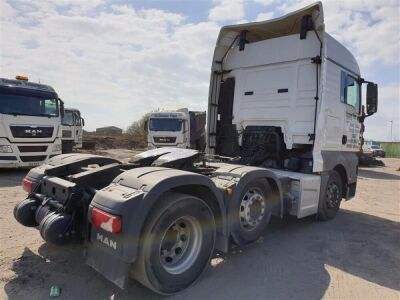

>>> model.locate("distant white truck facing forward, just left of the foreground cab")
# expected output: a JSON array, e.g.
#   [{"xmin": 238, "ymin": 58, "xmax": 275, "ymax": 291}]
[{"xmin": 145, "ymin": 108, "xmax": 206, "ymax": 151}]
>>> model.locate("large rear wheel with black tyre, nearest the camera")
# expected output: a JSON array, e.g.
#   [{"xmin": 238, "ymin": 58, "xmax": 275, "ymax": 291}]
[{"xmin": 131, "ymin": 192, "xmax": 216, "ymax": 295}]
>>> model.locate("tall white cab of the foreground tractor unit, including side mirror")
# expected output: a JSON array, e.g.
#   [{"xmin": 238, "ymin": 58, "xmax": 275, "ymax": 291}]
[{"xmin": 207, "ymin": 2, "xmax": 377, "ymax": 197}]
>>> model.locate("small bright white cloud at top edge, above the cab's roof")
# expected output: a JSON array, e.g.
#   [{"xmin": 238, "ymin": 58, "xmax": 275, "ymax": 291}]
[{"xmin": 208, "ymin": 0, "xmax": 245, "ymax": 22}]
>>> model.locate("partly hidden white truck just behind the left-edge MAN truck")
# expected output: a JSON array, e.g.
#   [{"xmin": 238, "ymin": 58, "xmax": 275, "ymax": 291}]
[{"xmin": 61, "ymin": 108, "xmax": 85, "ymax": 153}]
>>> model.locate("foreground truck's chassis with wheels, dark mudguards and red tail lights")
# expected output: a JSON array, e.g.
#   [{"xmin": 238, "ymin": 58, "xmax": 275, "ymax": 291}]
[{"xmin": 14, "ymin": 148, "xmax": 344, "ymax": 295}]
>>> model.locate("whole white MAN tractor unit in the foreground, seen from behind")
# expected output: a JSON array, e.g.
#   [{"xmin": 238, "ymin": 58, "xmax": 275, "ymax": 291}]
[{"xmin": 14, "ymin": 2, "xmax": 377, "ymax": 295}]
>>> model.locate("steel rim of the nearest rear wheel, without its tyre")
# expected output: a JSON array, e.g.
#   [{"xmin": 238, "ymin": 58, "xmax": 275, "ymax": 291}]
[{"xmin": 159, "ymin": 216, "xmax": 202, "ymax": 274}]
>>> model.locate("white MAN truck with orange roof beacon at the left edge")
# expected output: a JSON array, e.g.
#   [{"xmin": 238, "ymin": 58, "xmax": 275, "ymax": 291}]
[{"xmin": 0, "ymin": 76, "xmax": 63, "ymax": 168}]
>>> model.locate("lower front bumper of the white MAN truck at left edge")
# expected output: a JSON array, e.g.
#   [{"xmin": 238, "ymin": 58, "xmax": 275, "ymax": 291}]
[{"xmin": 0, "ymin": 139, "xmax": 61, "ymax": 168}]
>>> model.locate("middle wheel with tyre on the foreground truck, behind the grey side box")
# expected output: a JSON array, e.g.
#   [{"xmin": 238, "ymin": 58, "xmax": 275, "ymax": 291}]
[{"xmin": 231, "ymin": 179, "xmax": 272, "ymax": 246}]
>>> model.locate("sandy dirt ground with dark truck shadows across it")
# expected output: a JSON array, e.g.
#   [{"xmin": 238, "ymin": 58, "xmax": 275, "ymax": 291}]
[{"xmin": 0, "ymin": 150, "xmax": 400, "ymax": 299}]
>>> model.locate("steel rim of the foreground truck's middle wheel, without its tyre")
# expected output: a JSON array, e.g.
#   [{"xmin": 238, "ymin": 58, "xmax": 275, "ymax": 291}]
[{"xmin": 239, "ymin": 188, "xmax": 266, "ymax": 231}]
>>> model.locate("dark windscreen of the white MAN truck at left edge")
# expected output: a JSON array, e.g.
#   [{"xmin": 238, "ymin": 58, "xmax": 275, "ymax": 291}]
[{"xmin": 0, "ymin": 93, "xmax": 58, "ymax": 117}]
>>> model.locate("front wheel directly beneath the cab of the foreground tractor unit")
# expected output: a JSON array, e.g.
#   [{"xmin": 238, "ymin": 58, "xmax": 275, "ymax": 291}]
[{"xmin": 318, "ymin": 171, "xmax": 343, "ymax": 221}]
